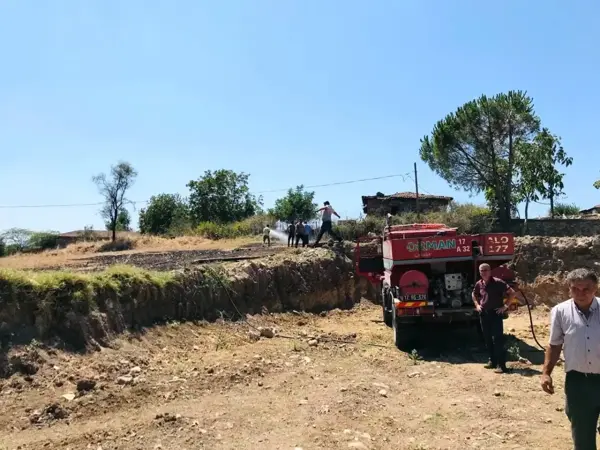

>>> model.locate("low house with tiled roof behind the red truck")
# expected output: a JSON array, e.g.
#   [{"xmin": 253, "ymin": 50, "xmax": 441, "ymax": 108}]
[{"xmin": 362, "ymin": 192, "xmax": 453, "ymax": 216}]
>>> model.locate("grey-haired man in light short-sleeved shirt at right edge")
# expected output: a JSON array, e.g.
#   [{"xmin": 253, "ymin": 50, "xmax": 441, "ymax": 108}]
[{"xmin": 541, "ymin": 269, "xmax": 600, "ymax": 450}]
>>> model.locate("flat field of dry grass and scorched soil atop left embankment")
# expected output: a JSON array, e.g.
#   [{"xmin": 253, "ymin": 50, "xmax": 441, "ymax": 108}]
[{"xmin": 0, "ymin": 238, "xmax": 287, "ymax": 272}]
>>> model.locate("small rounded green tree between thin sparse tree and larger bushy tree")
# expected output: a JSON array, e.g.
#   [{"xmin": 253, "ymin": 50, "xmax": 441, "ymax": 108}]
[{"xmin": 140, "ymin": 194, "xmax": 189, "ymax": 234}]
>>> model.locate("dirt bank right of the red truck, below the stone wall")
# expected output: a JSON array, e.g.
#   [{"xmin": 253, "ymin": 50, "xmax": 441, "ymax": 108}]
[{"xmin": 510, "ymin": 236, "xmax": 600, "ymax": 305}]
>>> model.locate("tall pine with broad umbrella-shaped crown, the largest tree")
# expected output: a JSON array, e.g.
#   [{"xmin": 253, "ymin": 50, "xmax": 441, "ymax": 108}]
[{"xmin": 420, "ymin": 91, "xmax": 540, "ymax": 229}]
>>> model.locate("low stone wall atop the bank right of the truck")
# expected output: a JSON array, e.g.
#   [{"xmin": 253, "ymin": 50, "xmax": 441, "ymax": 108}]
[{"xmin": 511, "ymin": 219, "xmax": 600, "ymax": 237}]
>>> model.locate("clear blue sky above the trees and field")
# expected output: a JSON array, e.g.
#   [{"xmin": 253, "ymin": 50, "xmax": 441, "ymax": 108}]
[{"xmin": 0, "ymin": 0, "xmax": 600, "ymax": 231}]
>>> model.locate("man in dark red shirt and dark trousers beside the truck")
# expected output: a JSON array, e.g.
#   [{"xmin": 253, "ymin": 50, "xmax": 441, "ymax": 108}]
[{"xmin": 472, "ymin": 263, "xmax": 514, "ymax": 373}]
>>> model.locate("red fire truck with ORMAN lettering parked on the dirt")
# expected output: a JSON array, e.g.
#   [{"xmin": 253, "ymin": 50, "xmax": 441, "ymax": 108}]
[{"xmin": 355, "ymin": 223, "xmax": 519, "ymax": 348}]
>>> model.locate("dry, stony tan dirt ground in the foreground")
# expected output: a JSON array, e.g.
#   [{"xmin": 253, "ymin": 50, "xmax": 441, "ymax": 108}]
[{"xmin": 0, "ymin": 301, "xmax": 572, "ymax": 450}]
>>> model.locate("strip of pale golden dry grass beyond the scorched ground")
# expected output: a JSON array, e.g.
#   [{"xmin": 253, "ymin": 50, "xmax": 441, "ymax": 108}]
[{"xmin": 0, "ymin": 235, "xmax": 257, "ymax": 270}]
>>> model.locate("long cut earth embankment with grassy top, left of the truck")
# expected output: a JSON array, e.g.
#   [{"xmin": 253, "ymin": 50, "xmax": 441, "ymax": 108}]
[{"xmin": 0, "ymin": 249, "xmax": 364, "ymax": 356}]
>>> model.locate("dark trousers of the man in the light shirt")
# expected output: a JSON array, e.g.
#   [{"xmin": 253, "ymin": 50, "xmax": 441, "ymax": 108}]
[{"xmin": 565, "ymin": 371, "xmax": 600, "ymax": 450}]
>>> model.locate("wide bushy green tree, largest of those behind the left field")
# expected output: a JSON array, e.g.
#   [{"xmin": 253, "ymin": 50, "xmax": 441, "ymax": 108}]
[{"xmin": 186, "ymin": 169, "xmax": 262, "ymax": 224}]
